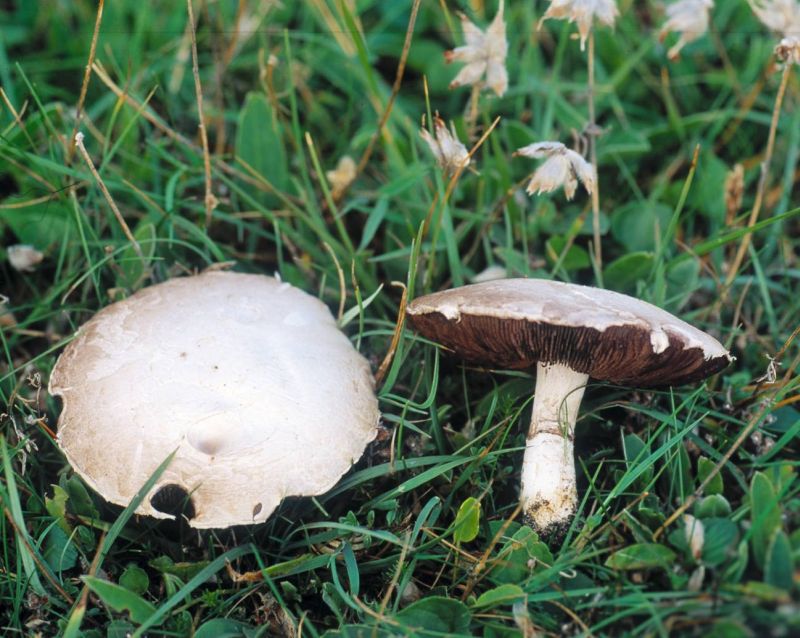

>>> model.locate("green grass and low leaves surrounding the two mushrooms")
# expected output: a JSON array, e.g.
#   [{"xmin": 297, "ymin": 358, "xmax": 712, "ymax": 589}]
[{"xmin": 0, "ymin": 0, "xmax": 800, "ymax": 637}]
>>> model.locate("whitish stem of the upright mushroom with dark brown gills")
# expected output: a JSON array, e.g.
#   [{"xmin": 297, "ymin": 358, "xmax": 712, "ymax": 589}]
[{"xmin": 520, "ymin": 363, "xmax": 589, "ymax": 532}]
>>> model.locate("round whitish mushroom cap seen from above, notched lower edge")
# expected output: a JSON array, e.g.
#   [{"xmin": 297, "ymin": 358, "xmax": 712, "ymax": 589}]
[{"xmin": 50, "ymin": 272, "xmax": 379, "ymax": 528}]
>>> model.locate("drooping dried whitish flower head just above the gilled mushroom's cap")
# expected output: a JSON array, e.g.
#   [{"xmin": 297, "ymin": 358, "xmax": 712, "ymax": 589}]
[{"xmin": 514, "ymin": 142, "xmax": 595, "ymax": 199}]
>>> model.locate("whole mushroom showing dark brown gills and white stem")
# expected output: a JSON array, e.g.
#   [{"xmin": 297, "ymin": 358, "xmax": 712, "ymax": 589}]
[{"xmin": 407, "ymin": 279, "xmax": 732, "ymax": 532}]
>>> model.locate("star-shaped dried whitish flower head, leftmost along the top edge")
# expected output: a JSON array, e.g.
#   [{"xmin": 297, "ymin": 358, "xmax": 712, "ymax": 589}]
[{"xmin": 444, "ymin": 0, "xmax": 508, "ymax": 97}]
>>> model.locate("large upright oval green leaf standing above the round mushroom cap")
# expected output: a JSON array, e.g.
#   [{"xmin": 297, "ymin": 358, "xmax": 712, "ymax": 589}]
[{"xmin": 236, "ymin": 92, "xmax": 289, "ymax": 206}]
